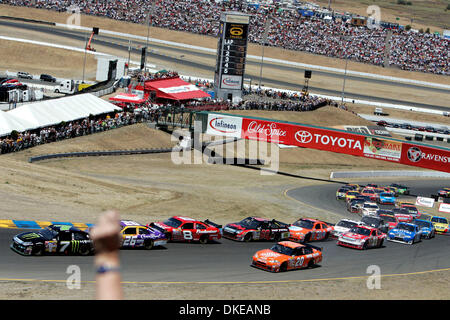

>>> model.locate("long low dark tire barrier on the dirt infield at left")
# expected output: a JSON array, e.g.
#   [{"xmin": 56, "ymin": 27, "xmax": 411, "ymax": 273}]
[{"xmin": 28, "ymin": 148, "xmax": 173, "ymax": 163}]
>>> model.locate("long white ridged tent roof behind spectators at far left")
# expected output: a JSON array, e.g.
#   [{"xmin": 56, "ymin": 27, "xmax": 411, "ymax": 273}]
[{"xmin": 8, "ymin": 93, "xmax": 122, "ymax": 131}]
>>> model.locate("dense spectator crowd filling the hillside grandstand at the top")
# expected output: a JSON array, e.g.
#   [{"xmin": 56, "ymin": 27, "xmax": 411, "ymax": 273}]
[{"xmin": 0, "ymin": 0, "xmax": 450, "ymax": 75}]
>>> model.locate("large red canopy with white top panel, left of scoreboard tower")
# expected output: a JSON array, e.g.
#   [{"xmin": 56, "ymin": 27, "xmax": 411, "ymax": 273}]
[{"xmin": 145, "ymin": 77, "xmax": 210, "ymax": 100}]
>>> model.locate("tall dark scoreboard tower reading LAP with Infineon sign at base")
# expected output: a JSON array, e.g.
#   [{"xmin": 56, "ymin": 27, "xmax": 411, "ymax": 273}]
[{"xmin": 214, "ymin": 12, "xmax": 250, "ymax": 101}]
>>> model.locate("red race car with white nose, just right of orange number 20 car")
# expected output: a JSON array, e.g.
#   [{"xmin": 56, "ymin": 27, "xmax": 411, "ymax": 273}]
[{"xmin": 337, "ymin": 225, "xmax": 386, "ymax": 250}]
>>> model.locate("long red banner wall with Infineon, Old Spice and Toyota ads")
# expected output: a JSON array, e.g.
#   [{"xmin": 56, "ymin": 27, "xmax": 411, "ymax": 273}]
[{"xmin": 203, "ymin": 113, "xmax": 450, "ymax": 172}]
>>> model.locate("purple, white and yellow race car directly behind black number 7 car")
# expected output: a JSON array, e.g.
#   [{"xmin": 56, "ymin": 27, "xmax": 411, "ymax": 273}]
[{"xmin": 120, "ymin": 220, "xmax": 167, "ymax": 250}]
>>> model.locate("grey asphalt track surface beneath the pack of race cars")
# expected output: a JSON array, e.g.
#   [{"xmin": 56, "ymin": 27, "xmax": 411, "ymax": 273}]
[{"xmin": 0, "ymin": 180, "xmax": 450, "ymax": 283}]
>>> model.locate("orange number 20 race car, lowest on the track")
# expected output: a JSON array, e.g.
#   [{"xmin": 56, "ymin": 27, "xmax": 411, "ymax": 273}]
[{"xmin": 251, "ymin": 241, "xmax": 322, "ymax": 272}]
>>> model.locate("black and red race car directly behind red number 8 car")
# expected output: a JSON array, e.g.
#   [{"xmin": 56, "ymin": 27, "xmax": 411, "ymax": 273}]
[{"xmin": 222, "ymin": 217, "xmax": 289, "ymax": 242}]
